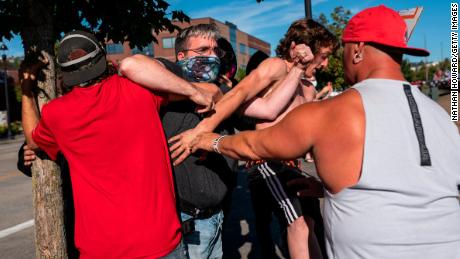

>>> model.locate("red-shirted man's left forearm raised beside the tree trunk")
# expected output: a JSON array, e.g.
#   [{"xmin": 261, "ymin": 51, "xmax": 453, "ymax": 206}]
[{"xmin": 22, "ymin": 88, "xmax": 39, "ymax": 149}]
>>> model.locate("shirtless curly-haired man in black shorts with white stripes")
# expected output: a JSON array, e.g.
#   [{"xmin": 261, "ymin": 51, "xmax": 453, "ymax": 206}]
[{"xmin": 170, "ymin": 19, "xmax": 337, "ymax": 258}]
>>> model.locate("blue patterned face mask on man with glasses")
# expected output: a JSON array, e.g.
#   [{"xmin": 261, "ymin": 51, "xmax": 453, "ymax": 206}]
[{"xmin": 177, "ymin": 56, "xmax": 220, "ymax": 82}]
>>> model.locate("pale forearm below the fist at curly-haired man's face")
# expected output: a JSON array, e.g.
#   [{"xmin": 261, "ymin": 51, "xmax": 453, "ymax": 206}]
[{"xmin": 243, "ymin": 67, "xmax": 304, "ymax": 120}]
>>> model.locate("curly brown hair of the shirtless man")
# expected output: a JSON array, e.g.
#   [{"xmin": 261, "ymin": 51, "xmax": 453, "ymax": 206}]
[{"xmin": 276, "ymin": 19, "xmax": 339, "ymax": 61}]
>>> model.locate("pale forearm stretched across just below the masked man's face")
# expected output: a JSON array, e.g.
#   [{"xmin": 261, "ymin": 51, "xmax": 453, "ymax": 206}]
[{"xmin": 120, "ymin": 55, "xmax": 197, "ymax": 97}]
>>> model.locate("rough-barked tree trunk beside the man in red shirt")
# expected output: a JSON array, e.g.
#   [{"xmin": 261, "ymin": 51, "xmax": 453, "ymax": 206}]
[{"xmin": 21, "ymin": 0, "xmax": 67, "ymax": 259}]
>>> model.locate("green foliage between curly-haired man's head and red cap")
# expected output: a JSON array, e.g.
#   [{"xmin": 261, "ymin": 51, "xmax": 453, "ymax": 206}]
[{"xmin": 316, "ymin": 6, "xmax": 351, "ymax": 89}]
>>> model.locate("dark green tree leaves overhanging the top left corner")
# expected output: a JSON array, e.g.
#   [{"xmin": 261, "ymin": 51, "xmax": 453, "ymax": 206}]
[{"xmin": 0, "ymin": 0, "xmax": 190, "ymax": 48}]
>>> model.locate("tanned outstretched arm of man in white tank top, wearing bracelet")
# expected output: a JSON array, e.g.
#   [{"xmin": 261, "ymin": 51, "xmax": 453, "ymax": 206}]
[{"xmin": 193, "ymin": 103, "xmax": 321, "ymax": 160}]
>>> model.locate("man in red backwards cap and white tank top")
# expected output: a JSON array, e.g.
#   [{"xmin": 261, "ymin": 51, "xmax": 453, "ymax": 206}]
[{"xmin": 193, "ymin": 6, "xmax": 460, "ymax": 259}]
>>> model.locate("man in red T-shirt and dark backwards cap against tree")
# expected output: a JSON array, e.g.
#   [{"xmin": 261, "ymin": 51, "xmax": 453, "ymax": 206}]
[{"xmin": 21, "ymin": 31, "xmax": 213, "ymax": 258}]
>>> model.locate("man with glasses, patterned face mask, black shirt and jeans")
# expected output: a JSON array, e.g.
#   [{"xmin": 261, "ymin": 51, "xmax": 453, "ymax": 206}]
[{"xmin": 156, "ymin": 24, "xmax": 235, "ymax": 259}]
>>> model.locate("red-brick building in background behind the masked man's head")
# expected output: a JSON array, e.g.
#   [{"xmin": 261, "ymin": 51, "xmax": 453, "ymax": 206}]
[{"xmin": 106, "ymin": 17, "xmax": 271, "ymax": 68}]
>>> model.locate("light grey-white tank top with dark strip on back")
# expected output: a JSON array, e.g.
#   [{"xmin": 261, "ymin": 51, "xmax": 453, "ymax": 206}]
[{"xmin": 324, "ymin": 79, "xmax": 460, "ymax": 259}]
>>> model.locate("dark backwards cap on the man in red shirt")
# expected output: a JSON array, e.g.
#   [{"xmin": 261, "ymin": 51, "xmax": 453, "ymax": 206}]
[{"xmin": 57, "ymin": 31, "xmax": 107, "ymax": 86}]
